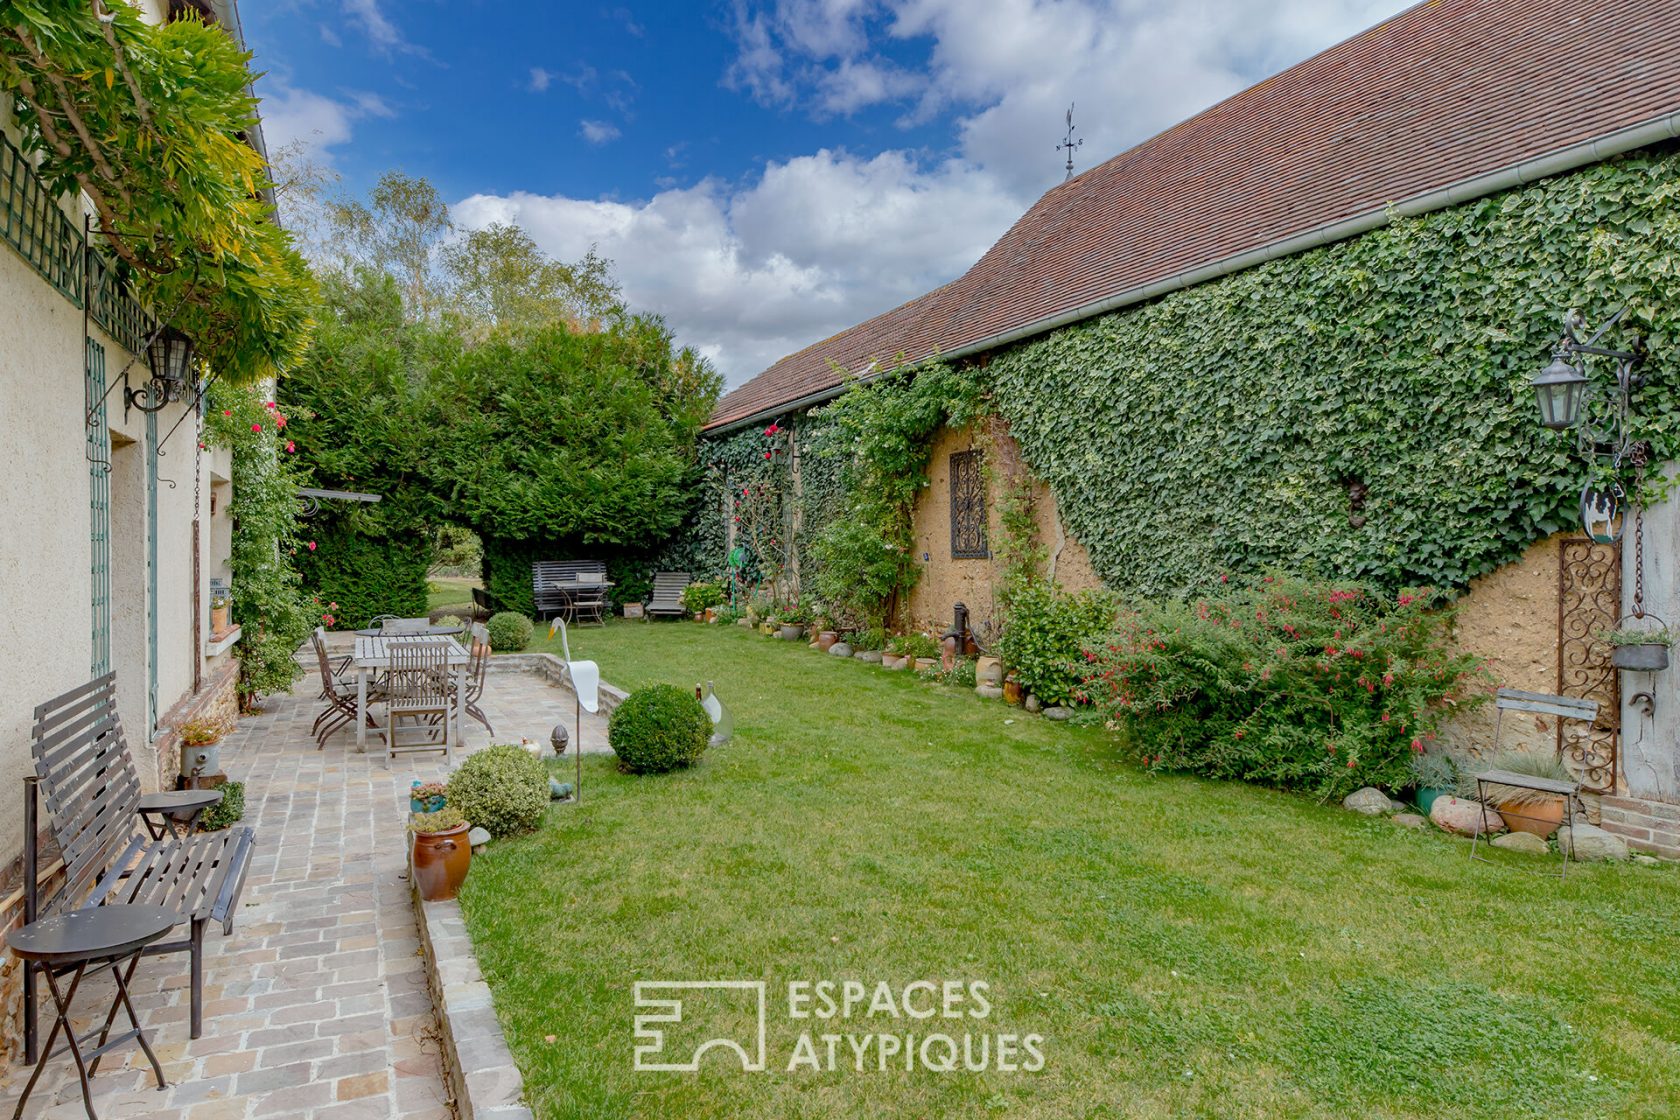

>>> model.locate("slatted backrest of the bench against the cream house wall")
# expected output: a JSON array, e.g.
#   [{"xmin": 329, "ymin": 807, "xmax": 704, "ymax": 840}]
[{"xmin": 25, "ymin": 673, "xmax": 139, "ymax": 907}]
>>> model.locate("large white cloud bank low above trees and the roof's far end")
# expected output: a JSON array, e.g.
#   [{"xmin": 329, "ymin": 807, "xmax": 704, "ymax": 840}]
[{"xmin": 454, "ymin": 149, "xmax": 1016, "ymax": 385}]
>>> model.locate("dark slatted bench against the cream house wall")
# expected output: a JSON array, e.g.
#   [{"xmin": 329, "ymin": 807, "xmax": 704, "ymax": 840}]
[{"xmin": 24, "ymin": 673, "xmax": 255, "ymax": 1061}]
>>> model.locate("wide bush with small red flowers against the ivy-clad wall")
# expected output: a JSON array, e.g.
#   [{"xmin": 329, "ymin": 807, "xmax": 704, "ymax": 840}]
[{"xmin": 1082, "ymin": 578, "xmax": 1480, "ymax": 798}]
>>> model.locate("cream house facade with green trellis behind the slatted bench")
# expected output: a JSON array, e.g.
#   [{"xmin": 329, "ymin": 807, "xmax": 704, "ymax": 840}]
[{"xmin": 0, "ymin": 0, "xmax": 260, "ymax": 1046}]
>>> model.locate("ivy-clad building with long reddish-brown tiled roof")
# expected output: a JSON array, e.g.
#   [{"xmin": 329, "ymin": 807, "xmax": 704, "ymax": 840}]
[{"xmin": 692, "ymin": 0, "xmax": 1680, "ymax": 856}]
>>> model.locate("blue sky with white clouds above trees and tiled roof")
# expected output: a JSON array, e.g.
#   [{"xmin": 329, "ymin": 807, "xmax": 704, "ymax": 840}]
[{"xmin": 240, "ymin": 0, "xmax": 1406, "ymax": 386}]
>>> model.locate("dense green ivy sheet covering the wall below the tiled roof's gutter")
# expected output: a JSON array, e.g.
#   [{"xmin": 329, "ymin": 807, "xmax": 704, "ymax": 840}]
[{"xmin": 990, "ymin": 149, "xmax": 1680, "ymax": 594}]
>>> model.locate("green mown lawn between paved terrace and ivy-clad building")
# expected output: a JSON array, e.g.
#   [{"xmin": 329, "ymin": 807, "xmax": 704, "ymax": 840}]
[{"xmin": 462, "ymin": 621, "xmax": 1680, "ymax": 1120}]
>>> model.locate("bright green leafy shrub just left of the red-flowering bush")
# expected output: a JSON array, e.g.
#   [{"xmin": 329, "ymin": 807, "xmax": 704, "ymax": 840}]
[{"xmin": 996, "ymin": 581, "xmax": 1114, "ymax": 707}]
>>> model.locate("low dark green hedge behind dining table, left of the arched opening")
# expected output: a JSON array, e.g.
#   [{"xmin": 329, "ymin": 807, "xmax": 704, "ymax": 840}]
[{"xmin": 297, "ymin": 522, "xmax": 432, "ymax": 630}]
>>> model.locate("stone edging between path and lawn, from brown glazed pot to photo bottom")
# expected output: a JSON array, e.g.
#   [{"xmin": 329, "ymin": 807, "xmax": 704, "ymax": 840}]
[{"xmin": 408, "ymin": 870, "xmax": 533, "ymax": 1120}]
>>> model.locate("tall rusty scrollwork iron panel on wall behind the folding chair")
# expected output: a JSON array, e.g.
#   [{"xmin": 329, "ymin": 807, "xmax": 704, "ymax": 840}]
[{"xmin": 1557, "ymin": 537, "xmax": 1621, "ymax": 793}]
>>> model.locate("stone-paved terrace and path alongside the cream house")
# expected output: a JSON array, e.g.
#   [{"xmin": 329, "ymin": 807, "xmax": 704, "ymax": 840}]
[{"xmin": 0, "ymin": 661, "xmax": 606, "ymax": 1120}]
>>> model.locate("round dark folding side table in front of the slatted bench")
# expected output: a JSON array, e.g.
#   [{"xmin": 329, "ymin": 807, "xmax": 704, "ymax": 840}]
[{"xmin": 5, "ymin": 903, "xmax": 181, "ymax": 1120}]
